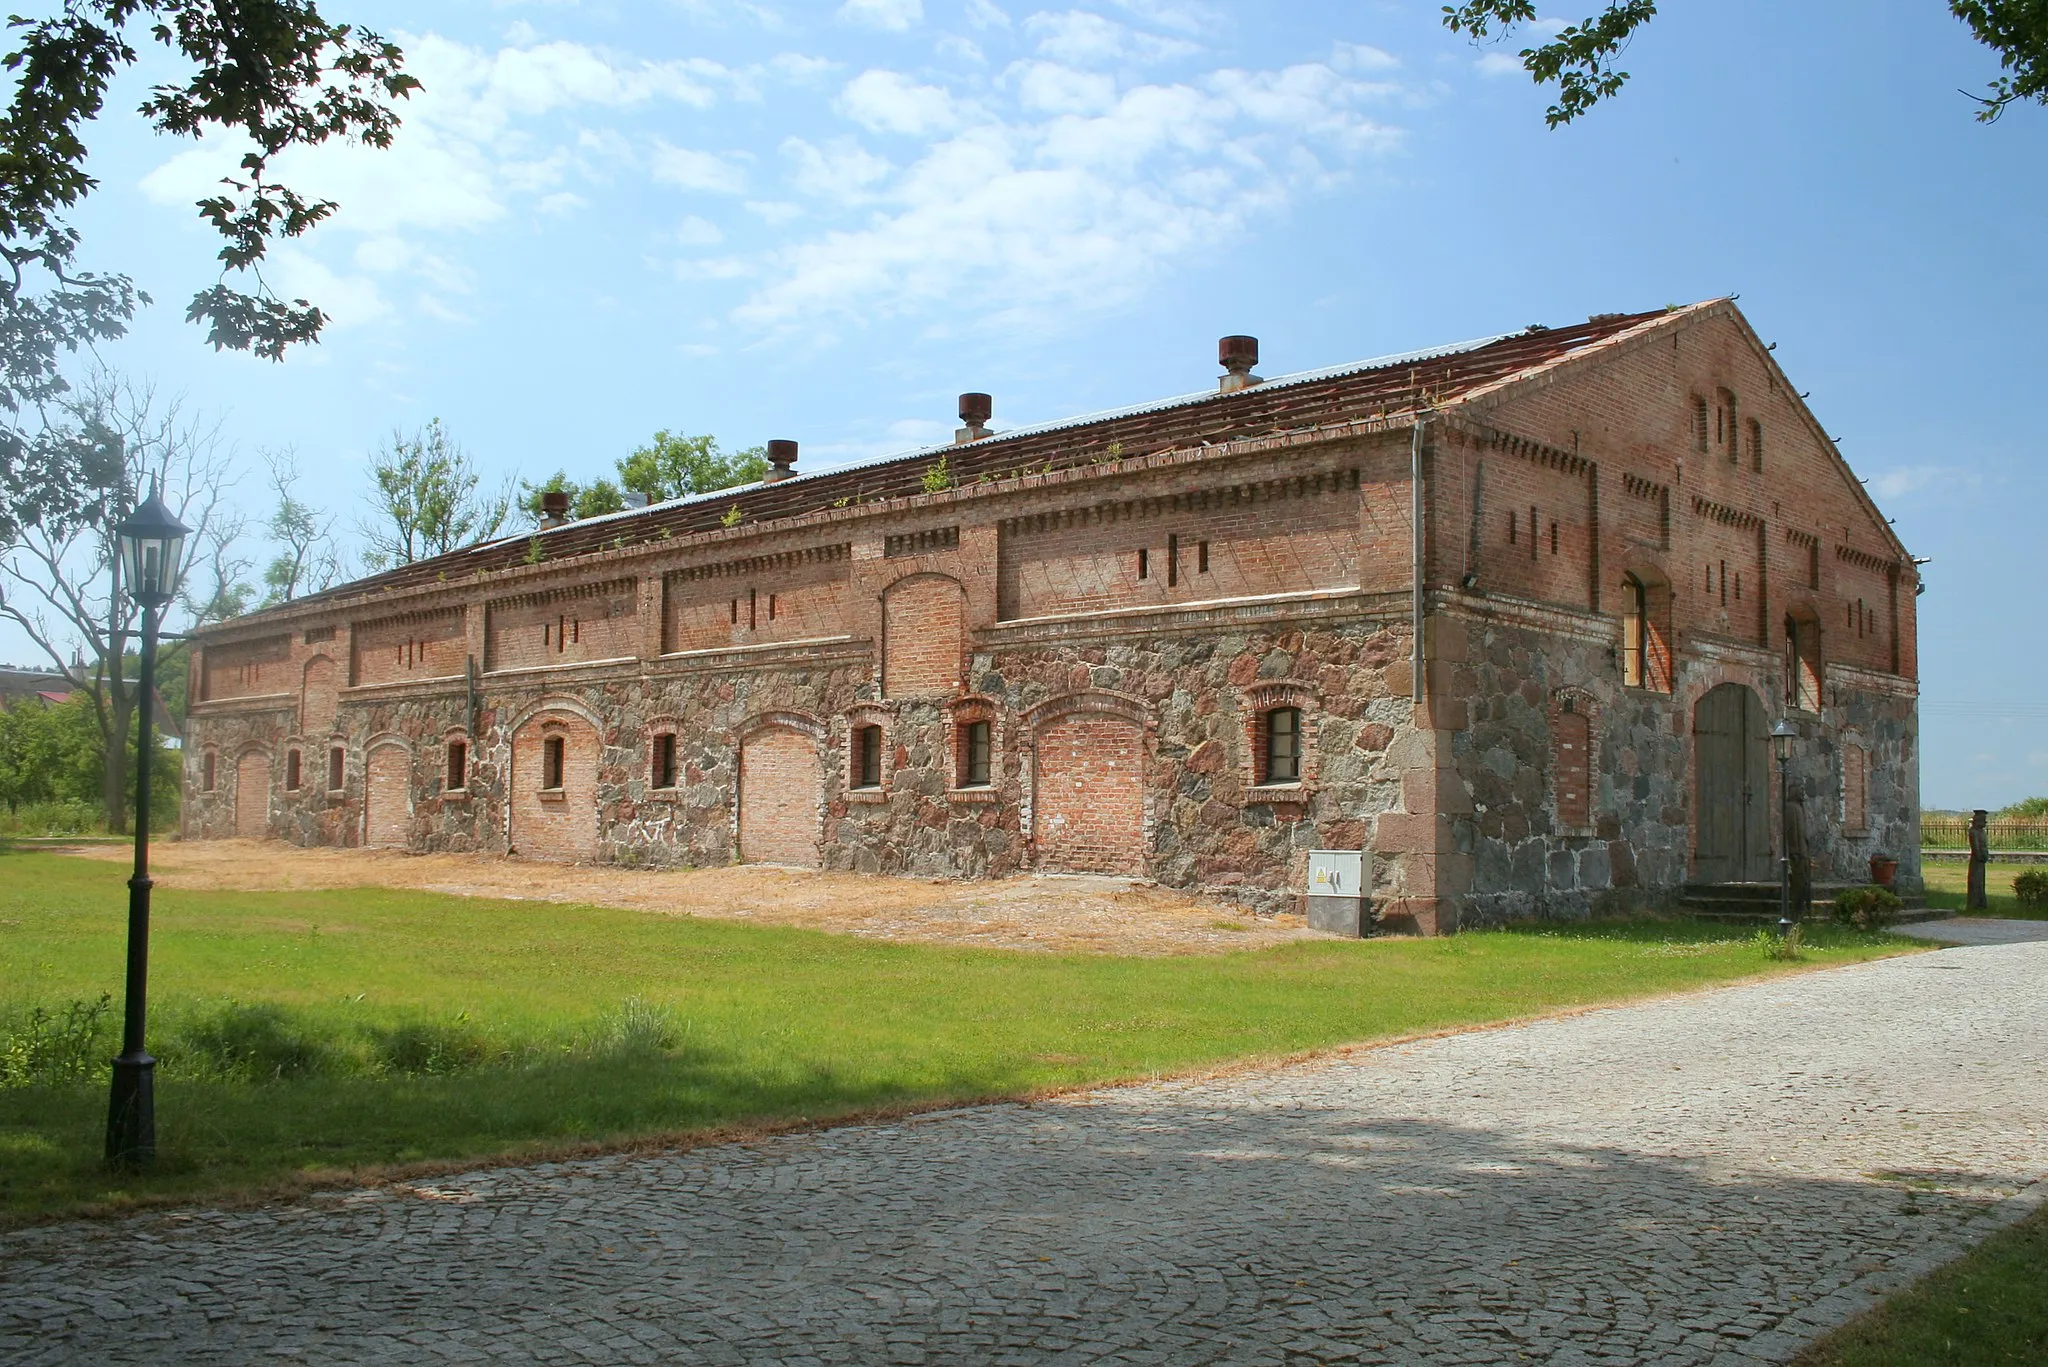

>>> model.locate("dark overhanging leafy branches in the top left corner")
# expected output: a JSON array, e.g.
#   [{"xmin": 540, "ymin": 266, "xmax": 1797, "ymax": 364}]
[{"xmin": 0, "ymin": 0, "xmax": 420, "ymax": 539}]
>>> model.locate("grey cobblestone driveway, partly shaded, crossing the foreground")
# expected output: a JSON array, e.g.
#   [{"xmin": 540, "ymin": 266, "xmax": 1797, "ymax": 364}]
[{"xmin": 0, "ymin": 943, "xmax": 2048, "ymax": 1363}]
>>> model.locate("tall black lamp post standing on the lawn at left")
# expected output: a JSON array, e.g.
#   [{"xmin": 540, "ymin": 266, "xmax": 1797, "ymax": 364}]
[{"xmin": 106, "ymin": 484, "xmax": 190, "ymax": 1168}]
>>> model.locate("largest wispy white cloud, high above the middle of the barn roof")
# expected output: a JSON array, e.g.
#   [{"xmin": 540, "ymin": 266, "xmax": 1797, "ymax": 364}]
[{"xmin": 735, "ymin": 61, "xmax": 1401, "ymax": 330}]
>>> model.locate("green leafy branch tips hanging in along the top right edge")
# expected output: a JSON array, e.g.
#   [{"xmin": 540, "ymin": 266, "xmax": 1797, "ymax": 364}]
[{"xmin": 1444, "ymin": 0, "xmax": 2048, "ymax": 127}]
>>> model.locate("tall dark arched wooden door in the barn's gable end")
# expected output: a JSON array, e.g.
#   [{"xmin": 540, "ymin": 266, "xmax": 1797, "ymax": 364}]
[{"xmin": 1692, "ymin": 682, "xmax": 1772, "ymax": 883}]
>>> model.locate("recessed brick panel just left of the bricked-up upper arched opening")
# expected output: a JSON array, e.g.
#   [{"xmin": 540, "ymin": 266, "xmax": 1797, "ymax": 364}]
[{"xmin": 662, "ymin": 545, "xmax": 850, "ymax": 654}]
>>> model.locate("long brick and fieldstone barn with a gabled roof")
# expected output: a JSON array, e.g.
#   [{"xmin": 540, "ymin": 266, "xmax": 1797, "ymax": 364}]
[{"xmin": 184, "ymin": 299, "xmax": 1919, "ymax": 933}]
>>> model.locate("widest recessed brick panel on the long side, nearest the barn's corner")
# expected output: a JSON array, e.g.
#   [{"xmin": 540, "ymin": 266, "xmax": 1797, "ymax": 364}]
[{"xmin": 997, "ymin": 467, "xmax": 1360, "ymax": 621}]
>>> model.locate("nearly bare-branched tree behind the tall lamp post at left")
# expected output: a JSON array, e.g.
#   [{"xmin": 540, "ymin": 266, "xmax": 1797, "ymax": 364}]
[{"xmin": 0, "ymin": 371, "xmax": 246, "ymax": 832}]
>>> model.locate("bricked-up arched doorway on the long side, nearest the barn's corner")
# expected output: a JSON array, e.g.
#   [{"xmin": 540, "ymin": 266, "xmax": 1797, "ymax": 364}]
[{"xmin": 1032, "ymin": 711, "xmax": 1145, "ymax": 877}]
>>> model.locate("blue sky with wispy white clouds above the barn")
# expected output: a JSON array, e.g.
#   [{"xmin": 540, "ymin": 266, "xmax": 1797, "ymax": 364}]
[{"xmin": 16, "ymin": 0, "xmax": 2048, "ymax": 805}]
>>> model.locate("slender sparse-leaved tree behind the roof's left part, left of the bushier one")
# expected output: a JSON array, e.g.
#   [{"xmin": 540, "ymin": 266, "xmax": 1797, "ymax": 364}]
[{"xmin": 362, "ymin": 418, "xmax": 512, "ymax": 570}]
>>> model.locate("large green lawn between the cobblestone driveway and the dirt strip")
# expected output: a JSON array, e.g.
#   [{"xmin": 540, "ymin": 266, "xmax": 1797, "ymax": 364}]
[{"xmin": 0, "ymin": 853, "xmax": 1913, "ymax": 1221}]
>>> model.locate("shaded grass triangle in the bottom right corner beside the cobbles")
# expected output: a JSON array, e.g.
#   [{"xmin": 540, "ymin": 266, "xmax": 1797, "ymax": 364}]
[{"xmin": 1792, "ymin": 1205, "xmax": 2048, "ymax": 1367}]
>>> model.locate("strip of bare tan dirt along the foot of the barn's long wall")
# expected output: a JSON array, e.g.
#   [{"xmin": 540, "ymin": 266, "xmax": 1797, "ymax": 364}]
[{"xmin": 68, "ymin": 840, "xmax": 1327, "ymax": 955}]
